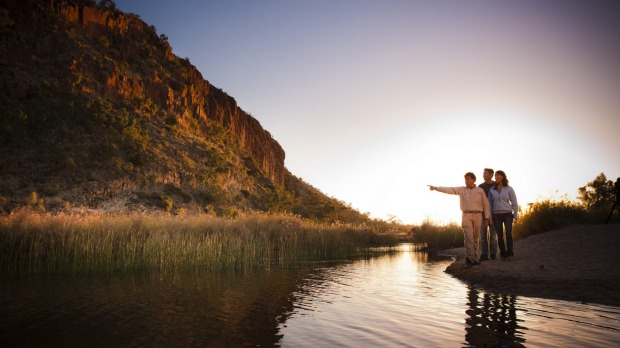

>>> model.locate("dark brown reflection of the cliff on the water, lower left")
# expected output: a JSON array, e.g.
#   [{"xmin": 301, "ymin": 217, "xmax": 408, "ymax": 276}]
[{"xmin": 0, "ymin": 267, "xmax": 320, "ymax": 347}]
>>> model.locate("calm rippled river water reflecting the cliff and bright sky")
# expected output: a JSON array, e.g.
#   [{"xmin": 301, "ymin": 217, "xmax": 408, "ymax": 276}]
[{"xmin": 0, "ymin": 245, "xmax": 620, "ymax": 347}]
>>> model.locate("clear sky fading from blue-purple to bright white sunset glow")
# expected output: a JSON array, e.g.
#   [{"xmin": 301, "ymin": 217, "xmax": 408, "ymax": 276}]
[{"xmin": 115, "ymin": 0, "xmax": 620, "ymax": 224}]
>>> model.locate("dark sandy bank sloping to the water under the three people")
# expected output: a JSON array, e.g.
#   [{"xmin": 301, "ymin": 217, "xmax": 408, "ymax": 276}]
[{"xmin": 442, "ymin": 224, "xmax": 620, "ymax": 306}]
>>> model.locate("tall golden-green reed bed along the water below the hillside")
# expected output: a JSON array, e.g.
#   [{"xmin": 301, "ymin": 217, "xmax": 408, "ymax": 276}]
[{"xmin": 0, "ymin": 212, "xmax": 397, "ymax": 275}]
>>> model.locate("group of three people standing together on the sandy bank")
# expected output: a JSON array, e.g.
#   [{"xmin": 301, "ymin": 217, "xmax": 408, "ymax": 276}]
[{"xmin": 429, "ymin": 168, "xmax": 519, "ymax": 267}]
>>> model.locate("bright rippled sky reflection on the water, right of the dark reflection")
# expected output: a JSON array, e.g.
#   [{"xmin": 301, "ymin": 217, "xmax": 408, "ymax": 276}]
[{"xmin": 280, "ymin": 248, "xmax": 620, "ymax": 347}]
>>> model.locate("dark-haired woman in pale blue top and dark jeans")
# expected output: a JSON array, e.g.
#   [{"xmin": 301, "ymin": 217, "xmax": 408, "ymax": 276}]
[{"xmin": 488, "ymin": 170, "xmax": 519, "ymax": 261}]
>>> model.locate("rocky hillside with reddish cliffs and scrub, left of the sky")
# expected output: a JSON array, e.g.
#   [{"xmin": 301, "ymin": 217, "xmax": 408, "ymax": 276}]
[{"xmin": 0, "ymin": 0, "xmax": 368, "ymax": 222}]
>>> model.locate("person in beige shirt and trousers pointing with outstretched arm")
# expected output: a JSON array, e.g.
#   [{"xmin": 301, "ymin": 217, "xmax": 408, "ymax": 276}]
[{"xmin": 428, "ymin": 172, "xmax": 490, "ymax": 268}]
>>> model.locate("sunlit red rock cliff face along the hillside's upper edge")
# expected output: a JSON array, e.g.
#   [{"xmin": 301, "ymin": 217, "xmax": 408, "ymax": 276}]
[{"xmin": 60, "ymin": 6, "xmax": 287, "ymax": 185}]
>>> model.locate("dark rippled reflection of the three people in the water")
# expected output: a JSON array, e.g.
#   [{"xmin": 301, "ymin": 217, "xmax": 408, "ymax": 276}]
[{"xmin": 465, "ymin": 287, "xmax": 525, "ymax": 347}]
